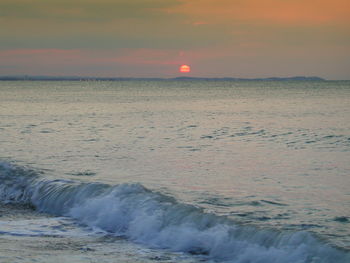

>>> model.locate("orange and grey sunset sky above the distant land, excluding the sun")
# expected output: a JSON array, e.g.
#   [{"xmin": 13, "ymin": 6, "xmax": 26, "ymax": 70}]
[{"xmin": 0, "ymin": 0, "xmax": 350, "ymax": 79}]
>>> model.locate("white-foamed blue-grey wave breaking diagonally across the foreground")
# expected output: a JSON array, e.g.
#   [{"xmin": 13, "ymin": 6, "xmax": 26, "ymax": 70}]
[{"xmin": 0, "ymin": 163, "xmax": 350, "ymax": 263}]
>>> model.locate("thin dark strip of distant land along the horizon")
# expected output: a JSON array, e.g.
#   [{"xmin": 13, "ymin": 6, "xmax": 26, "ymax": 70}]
[{"xmin": 0, "ymin": 76, "xmax": 326, "ymax": 81}]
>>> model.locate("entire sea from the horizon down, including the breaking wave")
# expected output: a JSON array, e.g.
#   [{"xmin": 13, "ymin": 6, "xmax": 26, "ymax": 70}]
[{"xmin": 0, "ymin": 80, "xmax": 350, "ymax": 263}]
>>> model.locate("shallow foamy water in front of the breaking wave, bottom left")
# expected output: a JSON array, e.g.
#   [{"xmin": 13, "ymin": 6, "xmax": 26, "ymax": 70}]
[{"xmin": 0, "ymin": 202, "xmax": 202, "ymax": 263}]
